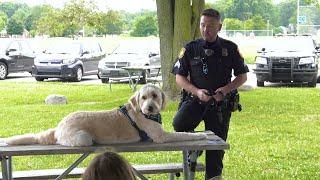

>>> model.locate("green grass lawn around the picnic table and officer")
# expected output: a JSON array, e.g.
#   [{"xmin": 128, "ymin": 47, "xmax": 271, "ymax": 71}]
[{"xmin": 0, "ymin": 81, "xmax": 320, "ymax": 180}]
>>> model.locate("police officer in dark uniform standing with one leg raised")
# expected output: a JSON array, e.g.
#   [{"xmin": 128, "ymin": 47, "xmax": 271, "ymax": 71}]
[{"xmin": 172, "ymin": 9, "xmax": 249, "ymax": 179}]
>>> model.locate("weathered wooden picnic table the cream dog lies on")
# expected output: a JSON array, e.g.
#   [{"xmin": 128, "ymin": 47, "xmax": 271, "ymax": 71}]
[{"xmin": 0, "ymin": 135, "xmax": 229, "ymax": 180}]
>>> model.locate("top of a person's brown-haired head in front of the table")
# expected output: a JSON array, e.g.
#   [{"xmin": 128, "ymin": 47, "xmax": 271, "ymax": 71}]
[{"xmin": 82, "ymin": 152, "xmax": 136, "ymax": 180}]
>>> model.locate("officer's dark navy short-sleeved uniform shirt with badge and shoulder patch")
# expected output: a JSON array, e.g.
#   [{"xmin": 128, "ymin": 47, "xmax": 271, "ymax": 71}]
[{"xmin": 172, "ymin": 37, "xmax": 249, "ymax": 92}]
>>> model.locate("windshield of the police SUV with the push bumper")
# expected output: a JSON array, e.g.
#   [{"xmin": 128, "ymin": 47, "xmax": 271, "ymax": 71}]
[{"xmin": 264, "ymin": 37, "xmax": 314, "ymax": 52}]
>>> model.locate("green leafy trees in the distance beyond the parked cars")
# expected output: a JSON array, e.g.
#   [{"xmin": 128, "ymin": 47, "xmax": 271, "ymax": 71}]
[{"xmin": 0, "ymin": 0, "xmax": 320, "ymax": 36}]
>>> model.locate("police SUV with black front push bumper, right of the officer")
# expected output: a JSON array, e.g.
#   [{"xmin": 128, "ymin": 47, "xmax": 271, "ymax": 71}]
[{"xmin": 253, "ymin": 36, "xmax": 320, "ymax": 87}]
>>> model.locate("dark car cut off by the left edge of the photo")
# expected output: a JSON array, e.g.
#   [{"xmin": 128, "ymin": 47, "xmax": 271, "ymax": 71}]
[{"xmin": 0, "ymin": 40, "xmax": 35, "ymax": 80}]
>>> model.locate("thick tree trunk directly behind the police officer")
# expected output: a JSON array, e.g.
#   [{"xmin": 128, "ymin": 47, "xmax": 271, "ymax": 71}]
[{"xmin": 157, "ymin": 0, "xmax": 204, "ymax": 99}]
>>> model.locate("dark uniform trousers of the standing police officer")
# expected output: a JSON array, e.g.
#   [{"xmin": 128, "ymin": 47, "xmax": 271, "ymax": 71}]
[{"xmin": 173, "ymin": 99, "xmax": 231, "ymax": 179}]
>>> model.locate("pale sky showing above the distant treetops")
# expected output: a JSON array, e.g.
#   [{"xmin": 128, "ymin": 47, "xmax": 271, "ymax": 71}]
[{"xmin": 0, "ymin": 0, "xmax": 282, "ymax": 13}]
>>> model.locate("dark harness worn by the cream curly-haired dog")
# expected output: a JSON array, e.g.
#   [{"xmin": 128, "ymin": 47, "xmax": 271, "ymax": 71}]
[{"xmin": 118, "ymin": 106, "xmax": 162, "ymax": 141}]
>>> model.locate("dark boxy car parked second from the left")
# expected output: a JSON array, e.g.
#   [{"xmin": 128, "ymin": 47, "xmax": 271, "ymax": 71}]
[{"xmin": 32, "ymin": 41, "xmax": 105, "ymax": 82}]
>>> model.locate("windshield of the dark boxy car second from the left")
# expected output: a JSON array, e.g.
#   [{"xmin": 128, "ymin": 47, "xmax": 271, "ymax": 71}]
[{"xmin": 45, "ymin": 43, "xmax": 81, "ymax": 55}]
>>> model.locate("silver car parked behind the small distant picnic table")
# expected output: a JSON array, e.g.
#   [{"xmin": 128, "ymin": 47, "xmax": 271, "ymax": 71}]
[{"xmin": 99, "ymin": 42, "xmax": 160, "ymax": 83}]
